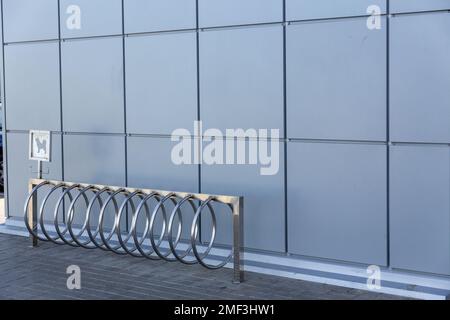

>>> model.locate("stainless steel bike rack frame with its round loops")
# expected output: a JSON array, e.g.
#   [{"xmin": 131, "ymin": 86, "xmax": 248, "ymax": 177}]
[{"xmin": 24, "ymin": 179, "xmax": 244, "ymax": 283}]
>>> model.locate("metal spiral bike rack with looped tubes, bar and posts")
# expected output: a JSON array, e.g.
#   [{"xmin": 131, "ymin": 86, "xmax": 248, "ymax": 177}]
[{"xmin": 24, "ymin": 179, "xmax": 244, "ymax": 283}]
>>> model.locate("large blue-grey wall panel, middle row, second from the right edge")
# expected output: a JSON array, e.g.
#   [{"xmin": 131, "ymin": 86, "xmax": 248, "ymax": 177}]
[{"xmin": 287, "ymin": 18, "xmax": 386, "ymax": 141}]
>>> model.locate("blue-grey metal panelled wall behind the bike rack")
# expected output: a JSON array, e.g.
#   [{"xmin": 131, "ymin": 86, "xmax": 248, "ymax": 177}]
[{"xmin": 2, "ymin": 0, "xmax": 450, "ymax": 274}]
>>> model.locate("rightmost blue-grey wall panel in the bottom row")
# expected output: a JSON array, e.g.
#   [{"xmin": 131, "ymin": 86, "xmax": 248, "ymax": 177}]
[{"xmin": 390, "ymin": 146, "xmax": 450, "ymax": 275}]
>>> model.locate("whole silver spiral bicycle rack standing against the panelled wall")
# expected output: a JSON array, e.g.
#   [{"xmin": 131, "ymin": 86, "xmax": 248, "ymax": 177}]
[{"xmin": 24, "ymin": 179, "xmax": 244, "ymax": 283}]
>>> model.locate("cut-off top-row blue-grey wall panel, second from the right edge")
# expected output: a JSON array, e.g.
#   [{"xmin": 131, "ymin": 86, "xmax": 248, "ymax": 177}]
[{"xmin": 286, "ymin": 0, "xmax": 386, "ymax": 21}]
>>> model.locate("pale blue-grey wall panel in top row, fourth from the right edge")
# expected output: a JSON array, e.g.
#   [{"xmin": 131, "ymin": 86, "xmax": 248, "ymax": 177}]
[{"xmin": 124, "ymin": 0, "xmax": 197, "ymax": 33}]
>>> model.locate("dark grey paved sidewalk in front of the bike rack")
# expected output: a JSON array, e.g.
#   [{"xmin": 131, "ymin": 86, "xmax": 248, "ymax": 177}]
[{"xmin": 0, "ymin": 234, "xmax": 408, "ymax": 300}]
